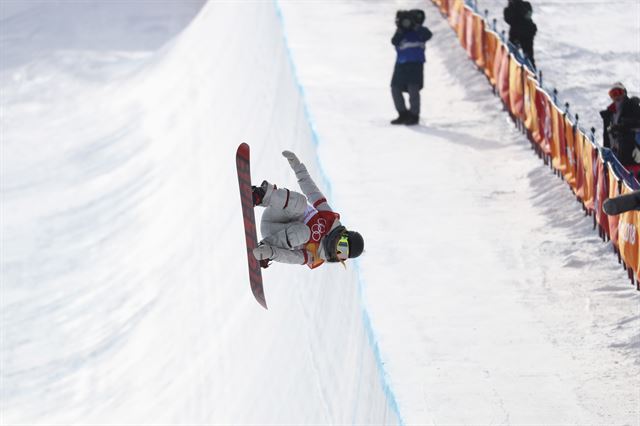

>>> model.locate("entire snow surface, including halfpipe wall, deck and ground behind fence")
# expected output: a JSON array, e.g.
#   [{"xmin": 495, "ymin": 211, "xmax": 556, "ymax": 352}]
[{"xmin": 0, "ymin": 0, "xmax": 640, "ymax": 425}]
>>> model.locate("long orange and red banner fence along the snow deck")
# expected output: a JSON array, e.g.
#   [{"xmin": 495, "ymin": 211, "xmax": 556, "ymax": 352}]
[{"xmin": 432, "ymin": 0, "xmax": 640, "ymax": 290}]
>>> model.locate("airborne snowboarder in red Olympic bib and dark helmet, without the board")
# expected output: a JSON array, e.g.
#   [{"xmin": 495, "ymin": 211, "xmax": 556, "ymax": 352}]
[{"xmin": 252, "ymin": 151, "xmax": 364, "ymax": 269}]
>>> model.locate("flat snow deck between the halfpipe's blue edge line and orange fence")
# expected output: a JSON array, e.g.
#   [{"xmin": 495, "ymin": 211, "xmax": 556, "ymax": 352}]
[{"xmin": 283, "ymin": 2, "xmax": 640, "ymax": 424}]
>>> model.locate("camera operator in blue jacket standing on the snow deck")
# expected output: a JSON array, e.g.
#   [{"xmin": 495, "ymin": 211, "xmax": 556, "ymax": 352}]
[{"xmin": 391, "ymin": 9, "xmax": 433, "ymax": 125}]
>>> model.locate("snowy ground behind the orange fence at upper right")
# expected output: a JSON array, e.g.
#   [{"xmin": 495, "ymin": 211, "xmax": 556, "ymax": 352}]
[{"xmin": 477, "ymin": 0, "xmax": 640, "ymax": 141}]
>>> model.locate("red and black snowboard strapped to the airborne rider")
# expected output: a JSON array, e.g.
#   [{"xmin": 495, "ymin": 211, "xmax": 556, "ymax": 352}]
[{"xmin": 236, "ymin": 143, "xmax": 267, "ymax": 309}]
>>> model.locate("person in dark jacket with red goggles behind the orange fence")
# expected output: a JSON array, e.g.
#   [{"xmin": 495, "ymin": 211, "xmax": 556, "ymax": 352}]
[{"xmin": 600, "ymin": 82, "xmax": 640, "ymax": 167}]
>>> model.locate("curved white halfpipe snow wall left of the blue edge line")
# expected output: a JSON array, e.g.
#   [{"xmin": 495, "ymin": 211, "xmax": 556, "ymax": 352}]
[{"xmin": 0, "ymin": 1, "xmax": 401, "ymax": 425}]
